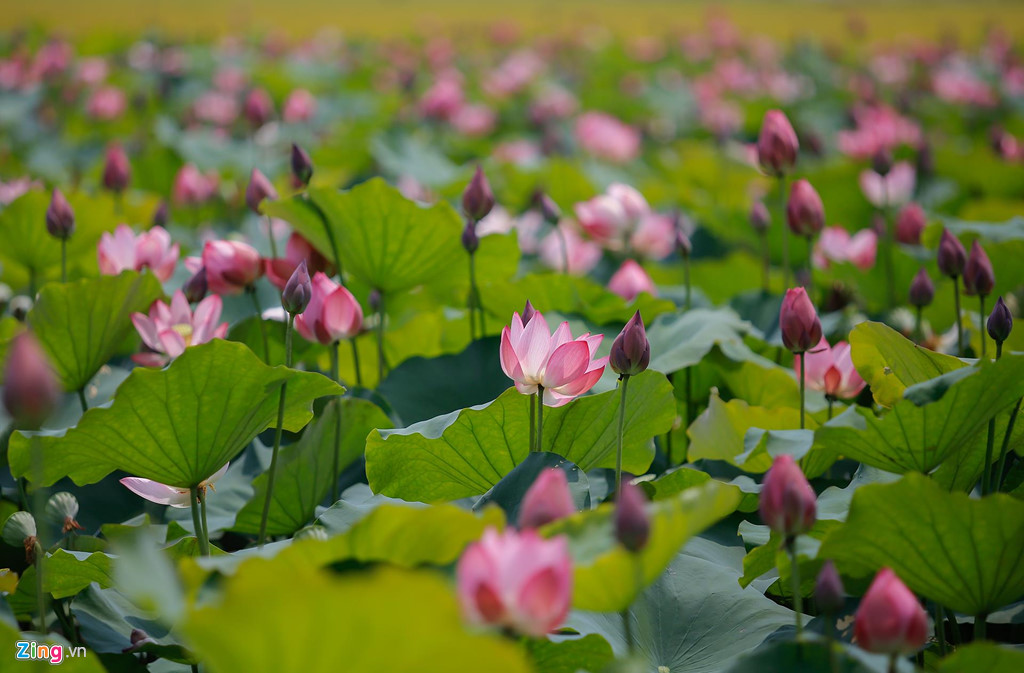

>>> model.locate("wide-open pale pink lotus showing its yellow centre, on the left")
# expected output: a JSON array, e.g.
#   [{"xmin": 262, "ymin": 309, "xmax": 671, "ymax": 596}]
[{"xmin": 131, "ymin": 290, "xmax": 227, "ymax": 367}]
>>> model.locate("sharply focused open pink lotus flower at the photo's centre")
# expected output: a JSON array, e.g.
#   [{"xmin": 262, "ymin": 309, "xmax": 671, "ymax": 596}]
[{"xmin": 501, "ymin": 311, "xmax": 608, "ymax": 407}]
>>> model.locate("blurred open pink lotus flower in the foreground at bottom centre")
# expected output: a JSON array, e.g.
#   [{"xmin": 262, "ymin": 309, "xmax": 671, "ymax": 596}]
[{"xmin": 456, "ymin": 528, "xmax": 572, "ymax": 637}]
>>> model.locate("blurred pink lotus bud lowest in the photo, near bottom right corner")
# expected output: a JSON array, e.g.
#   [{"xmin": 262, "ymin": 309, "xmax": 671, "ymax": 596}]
[{"xmin": 853, "ymin": 567, "xmax": 928, "ymax": 655}]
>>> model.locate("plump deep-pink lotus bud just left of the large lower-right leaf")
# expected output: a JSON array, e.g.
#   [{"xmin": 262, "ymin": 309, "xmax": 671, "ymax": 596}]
[{"xmin": 760, "ymin": 454, "xmax": 817, "ymax": 538}]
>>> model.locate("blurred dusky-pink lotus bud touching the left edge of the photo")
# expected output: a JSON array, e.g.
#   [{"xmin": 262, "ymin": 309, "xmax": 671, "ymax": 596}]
[{"xmin": 3, "ymin": 332, "xmax": 60, "ymax": 428}]
